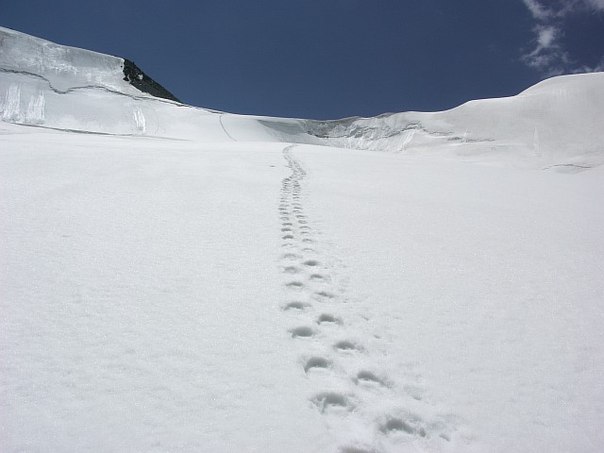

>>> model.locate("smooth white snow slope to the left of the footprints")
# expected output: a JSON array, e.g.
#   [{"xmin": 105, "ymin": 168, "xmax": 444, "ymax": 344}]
[{"xmin": 0, "ymin": 126, "xmax": 326, "ymax": 452}]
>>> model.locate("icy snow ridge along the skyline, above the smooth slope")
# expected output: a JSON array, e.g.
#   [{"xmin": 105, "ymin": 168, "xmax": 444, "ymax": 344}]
[{"xmin": 0, "ymin": 27, "xmax": 604, "ymax": 170}]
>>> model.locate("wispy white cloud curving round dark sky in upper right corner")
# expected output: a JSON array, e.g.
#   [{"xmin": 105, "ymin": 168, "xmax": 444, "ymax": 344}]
[{"xmin": 522, "ymin": 0, "xmax": 604, "ymax": 76}]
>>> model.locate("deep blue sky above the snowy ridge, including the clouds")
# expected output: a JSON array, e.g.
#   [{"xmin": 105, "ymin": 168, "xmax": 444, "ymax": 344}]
[{"xmin": 0, "ymin": 0, "xmax": 604, "ymax": 119}]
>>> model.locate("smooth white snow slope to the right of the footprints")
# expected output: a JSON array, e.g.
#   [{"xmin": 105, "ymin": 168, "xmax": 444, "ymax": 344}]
[{"xmin": 295, "ymin": 147, "xmax": 604, "ymax": 452}]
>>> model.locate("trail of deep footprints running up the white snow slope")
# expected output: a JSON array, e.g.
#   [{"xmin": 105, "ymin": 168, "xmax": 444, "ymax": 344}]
[{"xmin": 279, "ymin": 145, "xmax": 453, "ymax": 453}]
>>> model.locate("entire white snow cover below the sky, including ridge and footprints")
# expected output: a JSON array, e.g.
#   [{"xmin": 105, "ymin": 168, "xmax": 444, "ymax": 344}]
[{"xmin": 0, "ymin": 25, "xmax": 604, "ymax": 453}]
